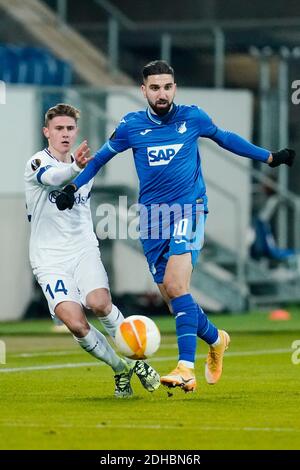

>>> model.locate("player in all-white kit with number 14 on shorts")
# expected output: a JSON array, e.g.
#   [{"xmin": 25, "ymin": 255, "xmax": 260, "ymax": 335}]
[{"xmin": 25, "ymin": 103, "xmax": 160, "ymax": 397}]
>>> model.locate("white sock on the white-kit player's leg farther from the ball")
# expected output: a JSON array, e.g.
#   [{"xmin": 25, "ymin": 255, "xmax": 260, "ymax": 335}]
[{"xmin": 74, "ymin": 324, "xmax": 124, "ymax": 372}]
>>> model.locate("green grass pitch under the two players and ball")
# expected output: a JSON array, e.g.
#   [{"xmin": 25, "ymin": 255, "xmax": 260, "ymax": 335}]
[{"xmin": 0, "ymin": 311, "xmax": 300, "ymax": 450}]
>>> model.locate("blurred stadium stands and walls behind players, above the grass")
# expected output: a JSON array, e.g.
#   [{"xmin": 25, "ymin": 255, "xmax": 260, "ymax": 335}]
[{"xmin": 0, "ymin": 0, "xmax": 300, "ymax": 320}]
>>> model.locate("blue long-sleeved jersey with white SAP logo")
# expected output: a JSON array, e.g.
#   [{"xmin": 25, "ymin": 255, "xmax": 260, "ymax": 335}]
[{"xmin": 74, "ymin": 104, "xmax": 270, "ymax": 205}]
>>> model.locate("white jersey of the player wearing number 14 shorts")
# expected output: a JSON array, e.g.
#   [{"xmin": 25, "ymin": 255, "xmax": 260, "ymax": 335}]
[{"xmin": 25, "ymin": 149, "xmax": 98, "ymax": 269}]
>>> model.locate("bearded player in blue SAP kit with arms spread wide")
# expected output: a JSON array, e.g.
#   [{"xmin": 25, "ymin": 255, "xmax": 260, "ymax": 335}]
[{"xmin": 56, "ymin": 60, "xmax": 295, "ymax": 392}]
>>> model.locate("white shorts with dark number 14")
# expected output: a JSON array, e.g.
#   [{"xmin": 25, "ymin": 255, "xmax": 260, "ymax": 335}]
[{"xmin": 33, "ymin": 247, "xmax": 109, "ymax": 317}]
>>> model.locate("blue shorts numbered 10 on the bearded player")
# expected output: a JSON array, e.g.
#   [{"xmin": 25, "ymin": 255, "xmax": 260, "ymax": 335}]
[{"xmin": 140, "ymin": 202, "xmax": 208, "ymax": 284}]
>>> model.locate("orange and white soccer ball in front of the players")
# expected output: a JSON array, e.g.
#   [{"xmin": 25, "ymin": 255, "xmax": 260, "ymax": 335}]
[{"xmin": 115, "ymin": 315, "xmax": 160, "ymax": 359}]
